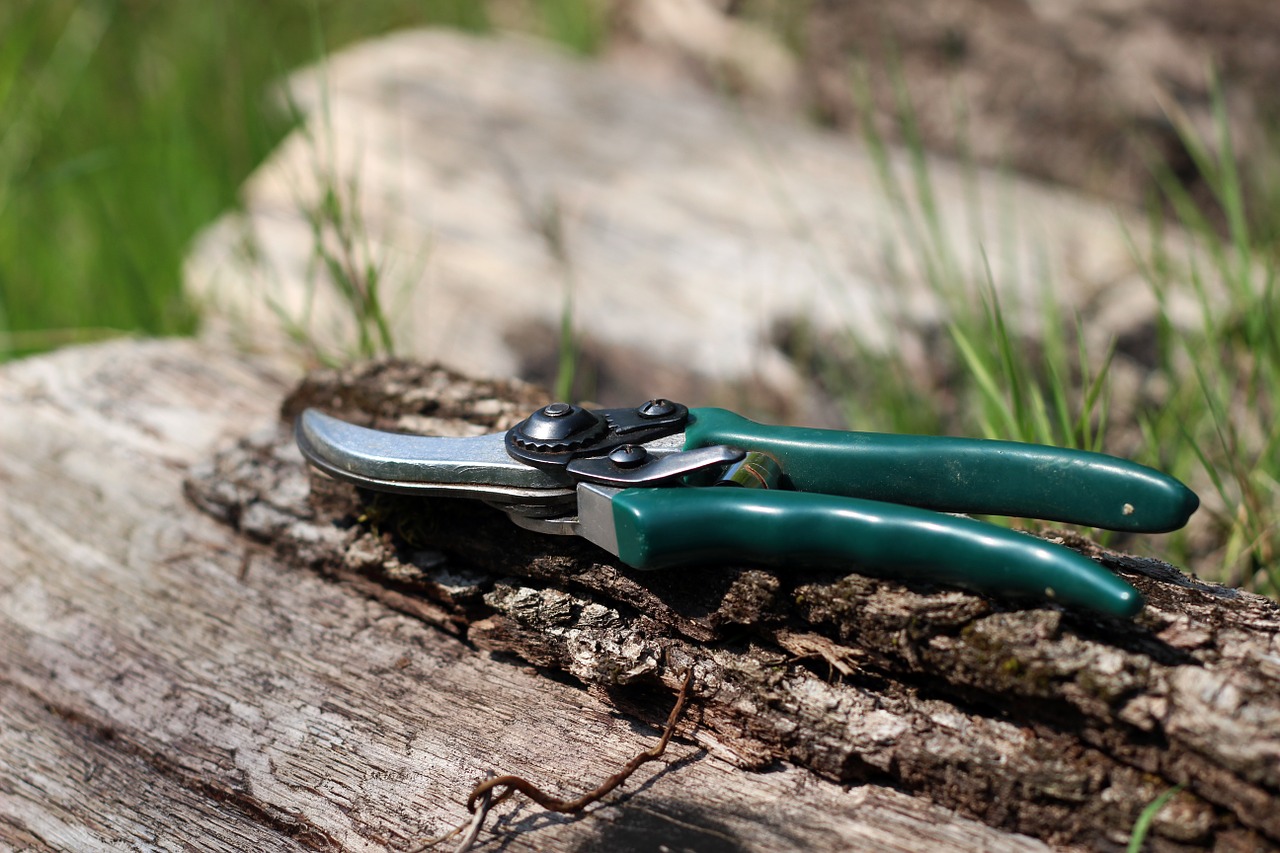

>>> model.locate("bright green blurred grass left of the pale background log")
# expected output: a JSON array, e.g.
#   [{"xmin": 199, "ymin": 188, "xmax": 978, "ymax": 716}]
[{"xmin": 0, "ymin": 0, "xmax": 489, "ymax": 359}]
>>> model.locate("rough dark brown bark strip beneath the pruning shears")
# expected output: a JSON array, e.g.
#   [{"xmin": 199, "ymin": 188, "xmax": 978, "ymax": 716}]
[{"xmin": 180, "ymin": 362, "xmax": 1280, "ymax": 850}]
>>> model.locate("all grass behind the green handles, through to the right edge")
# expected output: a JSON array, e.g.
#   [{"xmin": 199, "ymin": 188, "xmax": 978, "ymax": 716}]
[{"xmin": 827, "ymin": 61, "xmax": 1280, "ymax": 596}]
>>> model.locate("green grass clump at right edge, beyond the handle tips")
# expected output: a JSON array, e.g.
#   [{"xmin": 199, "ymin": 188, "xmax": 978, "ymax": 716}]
[{"xmin": 1143, "ymin": 78, "xmax": 1280, "ymax": 584}]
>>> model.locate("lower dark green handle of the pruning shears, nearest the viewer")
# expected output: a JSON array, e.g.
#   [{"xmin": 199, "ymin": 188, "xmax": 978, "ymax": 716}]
[{"xmin": 613, "ymin": 487, "xmax": 1143, "ymax": 617}]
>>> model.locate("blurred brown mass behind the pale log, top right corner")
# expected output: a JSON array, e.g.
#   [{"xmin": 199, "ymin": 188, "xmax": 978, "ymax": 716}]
[{"xmin": 801, "ymin": 0, "xmax": 1280, "ymax": 202}]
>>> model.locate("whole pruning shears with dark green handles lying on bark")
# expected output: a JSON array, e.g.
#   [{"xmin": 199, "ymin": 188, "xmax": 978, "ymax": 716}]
[{"xmin": 296, "ymin": 400, "xmax": 1199, "ymax": 616}]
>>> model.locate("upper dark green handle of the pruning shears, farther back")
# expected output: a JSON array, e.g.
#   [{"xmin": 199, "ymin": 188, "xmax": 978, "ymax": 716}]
[{"xmin": 685, "ymin": 409, "xmax": 1199, "ymax": 533}]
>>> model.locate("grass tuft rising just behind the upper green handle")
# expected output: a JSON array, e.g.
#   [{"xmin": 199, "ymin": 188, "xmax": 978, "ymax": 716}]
[{"xmin": 817, "ymin": 58, "xmax": 1114, "ymax": 450}]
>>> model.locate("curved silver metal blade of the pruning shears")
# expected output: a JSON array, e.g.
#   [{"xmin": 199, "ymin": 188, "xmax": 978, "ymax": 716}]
[{"xmin": 294, "ymin": 409, "xmax": 573, "ymax": 505}]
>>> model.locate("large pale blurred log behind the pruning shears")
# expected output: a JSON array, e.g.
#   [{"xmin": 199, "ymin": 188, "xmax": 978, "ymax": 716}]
[{"xmin": 188, "ymin": 31, "xmax": 1203, "ymax": 416}]
